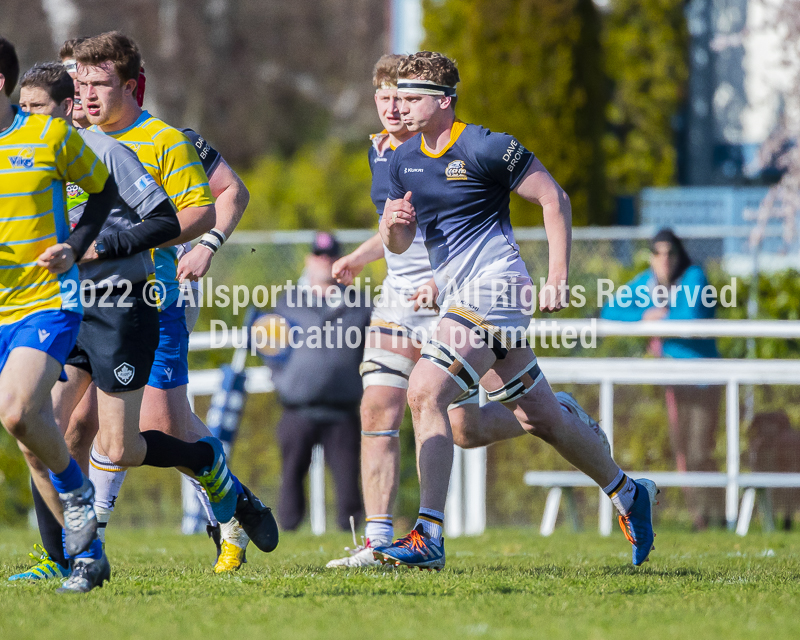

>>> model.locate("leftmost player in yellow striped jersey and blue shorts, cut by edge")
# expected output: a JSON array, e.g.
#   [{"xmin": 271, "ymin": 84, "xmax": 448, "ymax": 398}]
[{"xmin": 0, "ymin": 38, "xmax": 117, "ymax": 591}]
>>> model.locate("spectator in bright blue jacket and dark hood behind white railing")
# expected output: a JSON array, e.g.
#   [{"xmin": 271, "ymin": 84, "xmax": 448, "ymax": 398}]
[{"xmin": 600, "ymin": 229, "xmax": 722, "ymax": 530}]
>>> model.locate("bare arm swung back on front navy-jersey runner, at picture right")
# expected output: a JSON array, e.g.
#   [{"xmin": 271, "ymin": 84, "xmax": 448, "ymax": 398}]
[{"xmin": 515, "ymin": 158, "xmax": 572, "ymax": 311}]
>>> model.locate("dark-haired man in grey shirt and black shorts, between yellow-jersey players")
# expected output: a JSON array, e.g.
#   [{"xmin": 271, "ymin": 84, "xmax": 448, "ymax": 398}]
[{"xmin": 11, "ymin": 62, "xmax": 186, "ymax": 591}]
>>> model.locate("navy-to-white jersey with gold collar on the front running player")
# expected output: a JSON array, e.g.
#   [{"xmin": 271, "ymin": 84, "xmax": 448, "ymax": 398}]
[{"xmin": 389, "ymin": 120, "xmax": 534, "ymax": 289}]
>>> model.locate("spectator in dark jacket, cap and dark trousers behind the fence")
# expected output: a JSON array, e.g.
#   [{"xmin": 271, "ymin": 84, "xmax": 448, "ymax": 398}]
[{"xmin": 272, "ymin": 232, "xmax": 371, "ymax": 531}]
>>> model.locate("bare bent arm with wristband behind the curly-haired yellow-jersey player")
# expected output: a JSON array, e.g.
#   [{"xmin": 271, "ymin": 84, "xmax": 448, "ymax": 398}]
[{"xmin": 178, "ymin": 158, "xmax": 250, "ymax": 282}]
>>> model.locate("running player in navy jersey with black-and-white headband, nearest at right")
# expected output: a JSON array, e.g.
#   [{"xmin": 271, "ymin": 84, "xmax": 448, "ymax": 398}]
[{"xmin": 374, "ymin": 51, "xmax": 657, "ymax": 570}]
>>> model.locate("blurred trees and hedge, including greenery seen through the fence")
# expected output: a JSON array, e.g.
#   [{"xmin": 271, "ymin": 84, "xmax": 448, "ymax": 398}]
[{"xmin": 0, "ymin": 0, "xmax": 700, "ymax": 537}]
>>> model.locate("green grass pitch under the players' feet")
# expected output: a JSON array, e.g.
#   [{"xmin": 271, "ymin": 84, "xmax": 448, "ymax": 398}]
[{"xmin": 0, "ymin": 529, "xmax": 800, "ymax": 640}]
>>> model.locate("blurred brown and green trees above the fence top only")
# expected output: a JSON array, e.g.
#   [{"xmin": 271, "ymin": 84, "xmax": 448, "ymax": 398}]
[{"xmin": 0, "ymin": 0, "xmax": 687, "ymax": 229}]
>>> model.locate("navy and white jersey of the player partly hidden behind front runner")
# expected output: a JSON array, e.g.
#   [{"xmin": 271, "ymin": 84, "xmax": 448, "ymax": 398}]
[{"xmin": 368, "ymin": 130, "xmax": 433, "ymax": 296}]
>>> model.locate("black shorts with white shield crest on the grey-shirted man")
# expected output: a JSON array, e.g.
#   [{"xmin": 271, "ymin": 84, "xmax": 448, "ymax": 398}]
[{"xmin": 66, "ymin": 282, "xmax": 158, "ymax": 393}]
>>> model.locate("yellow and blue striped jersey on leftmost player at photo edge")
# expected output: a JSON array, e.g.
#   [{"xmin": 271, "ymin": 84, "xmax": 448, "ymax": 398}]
[{"xmin": 0, "ymin": 107, "xmax": 108, "ymax": 325}]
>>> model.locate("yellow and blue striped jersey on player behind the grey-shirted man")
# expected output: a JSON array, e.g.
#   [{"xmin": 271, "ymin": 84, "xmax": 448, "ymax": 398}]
[{"xmin": 92, "ymin": 111, "xmax": 214, "ymax": 309}]
